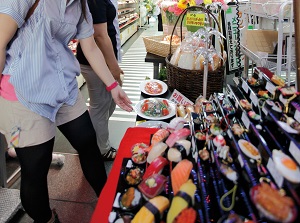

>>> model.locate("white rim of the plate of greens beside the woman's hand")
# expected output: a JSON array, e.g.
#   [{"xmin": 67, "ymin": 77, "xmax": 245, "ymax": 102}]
[{"xmin": 134, "ymin": 98, "xmax": 176, "ymax": 120}]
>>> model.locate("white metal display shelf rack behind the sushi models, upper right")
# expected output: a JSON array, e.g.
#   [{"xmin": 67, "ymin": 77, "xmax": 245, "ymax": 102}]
[{"xmin": 241, "ymin": 0, "xmax": 295, "ymax": 80}]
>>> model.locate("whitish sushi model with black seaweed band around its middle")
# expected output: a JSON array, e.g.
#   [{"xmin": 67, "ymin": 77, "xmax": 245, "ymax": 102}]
[{"xmin": 167, "ymin": 139, "xmax": 191, "ymax": 163}]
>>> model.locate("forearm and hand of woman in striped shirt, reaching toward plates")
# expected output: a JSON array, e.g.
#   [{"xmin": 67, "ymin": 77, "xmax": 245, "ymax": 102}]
[{"xmin": 80, "ymin": 36, "xmax": 132, "ymax": 111}]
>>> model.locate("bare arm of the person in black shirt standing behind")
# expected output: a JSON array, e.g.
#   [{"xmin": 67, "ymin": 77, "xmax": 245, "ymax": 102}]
[{"xmin": 94, "ymin": 23, "xmax": 123, "ymax": 83}]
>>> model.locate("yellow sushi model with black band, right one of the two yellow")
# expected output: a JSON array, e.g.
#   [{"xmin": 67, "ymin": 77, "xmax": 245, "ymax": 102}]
[{"xmin": 167, "ymin": 180, "xmax": 196, "ymax": 223}]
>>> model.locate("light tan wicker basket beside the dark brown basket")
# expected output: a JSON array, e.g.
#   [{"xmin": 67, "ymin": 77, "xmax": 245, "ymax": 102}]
[{"xmin": 143, "ymin": 35, "xmax": 180, "ymax": 57}]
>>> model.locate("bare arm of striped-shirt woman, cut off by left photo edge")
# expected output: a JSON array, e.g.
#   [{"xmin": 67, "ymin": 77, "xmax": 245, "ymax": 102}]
[{"xmin": 0, "ymin": 14, "xmax": 18, "ymax": 79}]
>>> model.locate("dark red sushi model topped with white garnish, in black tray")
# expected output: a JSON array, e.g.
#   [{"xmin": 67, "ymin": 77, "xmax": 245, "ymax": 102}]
[{"xmin": 138, "ymin": 174, "xmax": 167, "ymax": 200}]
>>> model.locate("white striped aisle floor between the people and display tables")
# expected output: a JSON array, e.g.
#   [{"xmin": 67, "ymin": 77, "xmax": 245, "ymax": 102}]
[{"xmin": 105, "ymin": 25, "xmax": 162, "ymax": 148}]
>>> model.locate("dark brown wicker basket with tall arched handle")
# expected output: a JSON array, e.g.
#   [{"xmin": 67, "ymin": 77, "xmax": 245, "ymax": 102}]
[{"xmin": 166, "ymin": 6, "xmax": 225, "ymax": 102}]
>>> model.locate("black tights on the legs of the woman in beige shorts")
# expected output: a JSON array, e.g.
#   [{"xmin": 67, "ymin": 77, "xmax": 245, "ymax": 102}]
[{"xmin": 16, "ymin": 112, "xmax": 107, "ymax": 223}]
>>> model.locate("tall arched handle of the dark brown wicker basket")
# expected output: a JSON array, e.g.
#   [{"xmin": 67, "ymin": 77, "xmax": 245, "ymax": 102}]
[{"xmin": 169, "ymin": 6, "xmax": 223, "ymax": 55}]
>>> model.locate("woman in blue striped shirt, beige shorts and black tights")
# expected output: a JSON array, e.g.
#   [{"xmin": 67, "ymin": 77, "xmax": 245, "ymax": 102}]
[{"xmin": 0, "ymin": 0, "xmax": 132, "ymax": 223}]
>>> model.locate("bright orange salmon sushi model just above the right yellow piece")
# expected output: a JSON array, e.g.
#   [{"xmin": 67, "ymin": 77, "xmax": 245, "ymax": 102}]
[{"xmin": 171, "ymin": 159, "xmax": 193, "ymax": 195}]
